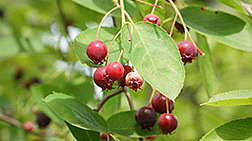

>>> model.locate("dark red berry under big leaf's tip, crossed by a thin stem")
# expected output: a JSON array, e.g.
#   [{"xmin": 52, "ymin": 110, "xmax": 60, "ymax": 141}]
[{"xmin": 151, "ymin": 92, "xmax": 174, "ymax": 114}]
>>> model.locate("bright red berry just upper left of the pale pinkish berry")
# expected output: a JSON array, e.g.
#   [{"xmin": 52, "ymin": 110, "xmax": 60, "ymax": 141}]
[{"xmin": 105, "ymin": 61, "xmax": 124, "ymax": 81}]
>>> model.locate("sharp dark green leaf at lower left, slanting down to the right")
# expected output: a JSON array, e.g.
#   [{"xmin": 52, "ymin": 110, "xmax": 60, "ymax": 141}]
[{"xmin": 44, "ymin": 93, "xmax": 107, "ymax": 132}]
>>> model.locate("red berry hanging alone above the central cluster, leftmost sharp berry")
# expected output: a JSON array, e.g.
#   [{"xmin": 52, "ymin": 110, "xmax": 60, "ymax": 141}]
[{"xmin": 87, "ymin": 41, "xmax": 107, "ymax": 64}]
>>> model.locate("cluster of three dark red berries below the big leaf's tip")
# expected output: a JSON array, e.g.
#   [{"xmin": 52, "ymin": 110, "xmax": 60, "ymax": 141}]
[{"xmin": 135, "ymin": 93, "xmax": 178, "ymax": 134}]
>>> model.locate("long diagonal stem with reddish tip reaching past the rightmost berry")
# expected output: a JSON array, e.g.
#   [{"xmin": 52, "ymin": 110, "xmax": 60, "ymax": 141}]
[{"xmin": 169, "ymin": 0, "xmax": 205, "ymax": 56}]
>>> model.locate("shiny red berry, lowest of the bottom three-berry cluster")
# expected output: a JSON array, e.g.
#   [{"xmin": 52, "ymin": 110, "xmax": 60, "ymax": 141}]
[{"xmin": 158, "ymin": 113, "xmax": 178, "ymax": 134}]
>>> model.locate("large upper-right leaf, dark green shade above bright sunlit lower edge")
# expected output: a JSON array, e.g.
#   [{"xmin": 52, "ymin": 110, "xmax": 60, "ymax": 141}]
[{"xmin": 180, "ymin": 7, "xmax": 252, "ymax": 51}]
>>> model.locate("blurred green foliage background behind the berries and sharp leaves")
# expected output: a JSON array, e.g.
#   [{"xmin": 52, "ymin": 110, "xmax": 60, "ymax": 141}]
[{"xmin": 0, "ymin": 0, "xmax": 252, "ymax": 141}]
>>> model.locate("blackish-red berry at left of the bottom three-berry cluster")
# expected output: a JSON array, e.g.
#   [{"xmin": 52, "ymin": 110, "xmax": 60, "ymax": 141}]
[{"xmin": 135, "ymin": 107, "xmax": 157, "ymax": 129}]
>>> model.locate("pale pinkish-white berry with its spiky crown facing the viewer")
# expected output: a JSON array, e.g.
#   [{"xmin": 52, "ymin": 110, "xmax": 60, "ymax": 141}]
[{"xmin": 125, "ymin": 72, "xmax": 143, "ymax": 91}]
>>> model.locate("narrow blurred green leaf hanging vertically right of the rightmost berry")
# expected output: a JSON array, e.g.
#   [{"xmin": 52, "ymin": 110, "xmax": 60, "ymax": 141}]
[{"xmin": 196, "ymin": 33, "xmax": 215, "ymax": 97}]
